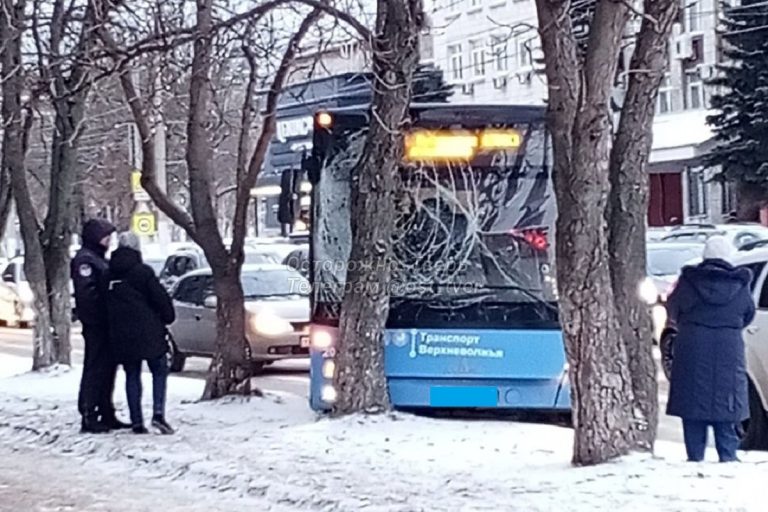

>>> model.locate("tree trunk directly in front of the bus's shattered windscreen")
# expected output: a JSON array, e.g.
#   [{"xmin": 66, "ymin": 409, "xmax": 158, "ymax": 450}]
[{"xmin": 334, "ymin": 0, "xmax": 423, "ymax": 414}]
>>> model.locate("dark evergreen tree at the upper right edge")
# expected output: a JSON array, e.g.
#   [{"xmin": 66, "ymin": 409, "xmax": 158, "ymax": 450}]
[{"xmin": 705, "ymin": 0, "xmax": 768, "ymax": 220}]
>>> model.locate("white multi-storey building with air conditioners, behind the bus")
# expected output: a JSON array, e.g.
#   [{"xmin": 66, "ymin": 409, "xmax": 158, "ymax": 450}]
[{"xmin": 430, "ymin": 0, "xmax": 734, "ymax": 225}]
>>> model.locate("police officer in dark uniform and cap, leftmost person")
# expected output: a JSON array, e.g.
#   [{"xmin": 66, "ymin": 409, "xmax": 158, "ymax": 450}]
[{"xmin": 70, "ymin": 219, "xmax": 130, "ymax": 433}]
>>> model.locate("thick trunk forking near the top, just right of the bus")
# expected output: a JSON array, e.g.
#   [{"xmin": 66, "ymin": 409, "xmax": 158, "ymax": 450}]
[{"xmin": 537, "ymin": 0, "xmax": 633, "ymax": 465}]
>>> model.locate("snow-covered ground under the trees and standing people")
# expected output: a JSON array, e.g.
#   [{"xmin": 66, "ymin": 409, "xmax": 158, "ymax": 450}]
[{"xmin": 0, "ymin": 356, "xmax": 768, "ymax": 512}]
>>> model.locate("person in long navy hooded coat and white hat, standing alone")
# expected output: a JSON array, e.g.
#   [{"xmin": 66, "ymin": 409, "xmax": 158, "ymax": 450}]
[{"xmin": 667, "ymin": 236, "xmax": 755, "ymax": 462}]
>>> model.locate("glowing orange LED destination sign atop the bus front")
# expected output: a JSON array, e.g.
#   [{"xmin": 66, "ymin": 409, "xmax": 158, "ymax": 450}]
[{"xmin": 405, "ymin": 129, "xmax": 522, "ymax": 162}]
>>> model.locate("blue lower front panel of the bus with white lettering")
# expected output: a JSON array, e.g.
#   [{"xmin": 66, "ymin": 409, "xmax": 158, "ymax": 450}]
[{"xmin": 310, "ymin": 329, "xmax": 570, "ymax": 411}]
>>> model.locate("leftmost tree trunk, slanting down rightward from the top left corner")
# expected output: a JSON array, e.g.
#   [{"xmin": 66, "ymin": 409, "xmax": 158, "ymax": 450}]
[{"xmin": 0, "ymin": 0, "xmax": 56, "ymax": 370}]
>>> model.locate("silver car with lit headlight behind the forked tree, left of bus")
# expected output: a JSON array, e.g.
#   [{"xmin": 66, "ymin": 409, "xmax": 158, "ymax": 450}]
[{"xmin": 170, "ymin": 264, "xmax": 309, "ymax": 371}]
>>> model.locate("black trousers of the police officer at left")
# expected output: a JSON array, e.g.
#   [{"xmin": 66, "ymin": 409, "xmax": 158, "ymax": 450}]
[{"xmin": 77, "ymin": 324, "xmax": 117, "ymax": 419}]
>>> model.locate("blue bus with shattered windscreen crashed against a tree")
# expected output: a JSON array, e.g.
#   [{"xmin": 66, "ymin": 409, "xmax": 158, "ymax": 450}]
[{"xmin": 304, "ymin": 104, "xmax": 570, "ymax": 412}]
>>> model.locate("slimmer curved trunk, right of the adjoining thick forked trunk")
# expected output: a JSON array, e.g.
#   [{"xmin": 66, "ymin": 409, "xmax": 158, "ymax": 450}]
[{"xmin": 607, "ymin": 0, "xmax": 679, "ymax": 451}]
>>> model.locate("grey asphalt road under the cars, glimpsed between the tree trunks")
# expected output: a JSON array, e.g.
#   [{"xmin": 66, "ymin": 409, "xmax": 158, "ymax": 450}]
[{"xmin": 0, "ymin": 327, "xmax": 683, "ymax": 442}]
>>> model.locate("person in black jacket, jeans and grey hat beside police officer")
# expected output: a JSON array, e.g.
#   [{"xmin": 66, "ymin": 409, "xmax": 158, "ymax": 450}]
[{"xmin": 104, "ymin": 233, "xmax": 175, "ymax": 434}]
